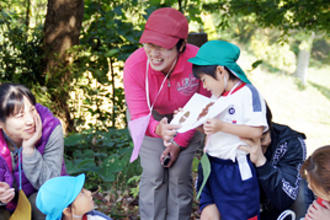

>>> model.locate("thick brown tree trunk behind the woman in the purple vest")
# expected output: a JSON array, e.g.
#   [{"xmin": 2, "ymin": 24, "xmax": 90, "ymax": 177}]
[{"xmin": 44, "ymin": 0, "xmax": 84, "ymax": 131}]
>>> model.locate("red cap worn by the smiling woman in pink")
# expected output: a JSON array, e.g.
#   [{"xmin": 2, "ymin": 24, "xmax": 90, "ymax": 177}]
[{"xmin": 140, "ymin": 8, "xmax": 188, "ymax": 49}]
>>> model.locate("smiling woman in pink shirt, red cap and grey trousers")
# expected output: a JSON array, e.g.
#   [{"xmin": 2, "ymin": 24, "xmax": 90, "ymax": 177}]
[{"xmin": 124, "ymin": 8, "xmax": 209, "ymax": 220}]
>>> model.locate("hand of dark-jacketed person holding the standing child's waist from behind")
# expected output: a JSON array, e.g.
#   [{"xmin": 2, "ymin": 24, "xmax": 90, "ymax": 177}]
[{"xmin": 239, "ymin": 138, "xmax": 267, "ymax": 167}]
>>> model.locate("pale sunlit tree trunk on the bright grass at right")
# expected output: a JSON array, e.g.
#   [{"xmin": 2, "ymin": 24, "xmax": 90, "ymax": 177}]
[{"xmin": 295, "ymin": 32, "xmax": 315, "ymax": 85}]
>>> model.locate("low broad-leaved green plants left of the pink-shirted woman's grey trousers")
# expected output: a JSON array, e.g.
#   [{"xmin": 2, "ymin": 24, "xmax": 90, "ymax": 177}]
[{"xmin": 65, "ymin": 129, "xmax": 141, "ymax": 191}]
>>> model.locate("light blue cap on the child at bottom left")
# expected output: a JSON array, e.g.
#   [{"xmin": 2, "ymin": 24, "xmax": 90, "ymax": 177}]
[{"xmin": 36, "ymin": 174, "xmax": 85, "ymax": 220}]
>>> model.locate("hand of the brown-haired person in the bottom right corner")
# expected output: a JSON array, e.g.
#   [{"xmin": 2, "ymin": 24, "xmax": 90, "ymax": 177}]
[{"xmin": 304, "ymin": 200, "xmax": 330, "ymax": 220}]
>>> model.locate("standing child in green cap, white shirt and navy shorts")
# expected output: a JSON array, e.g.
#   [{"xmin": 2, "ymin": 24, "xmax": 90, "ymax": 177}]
[{"xmin": 188, "ymin": 40, "xmax": 268, "ymax": 220}]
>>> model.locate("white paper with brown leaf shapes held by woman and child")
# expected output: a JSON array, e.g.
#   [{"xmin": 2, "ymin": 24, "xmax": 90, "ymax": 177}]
[{"xmin": 170, "ymin": 93, "xmax": 228, "ymax": 133}]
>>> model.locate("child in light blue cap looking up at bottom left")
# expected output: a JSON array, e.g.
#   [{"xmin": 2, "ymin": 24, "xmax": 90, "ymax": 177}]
[{"xmin": 36, "ymin": 174, "xmax": 111, "ymax": 220}]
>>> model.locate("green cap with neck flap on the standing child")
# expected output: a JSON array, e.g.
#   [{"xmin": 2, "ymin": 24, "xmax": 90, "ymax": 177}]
[{"xmin": 188, "ymin": 40, "xmax": 251, "ymax": 84}]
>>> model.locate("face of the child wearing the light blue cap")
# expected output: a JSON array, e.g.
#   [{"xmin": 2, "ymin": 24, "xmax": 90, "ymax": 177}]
[{"xmin": 72, "ymin": 188, "xmax": 94, "ymax": 215}]
